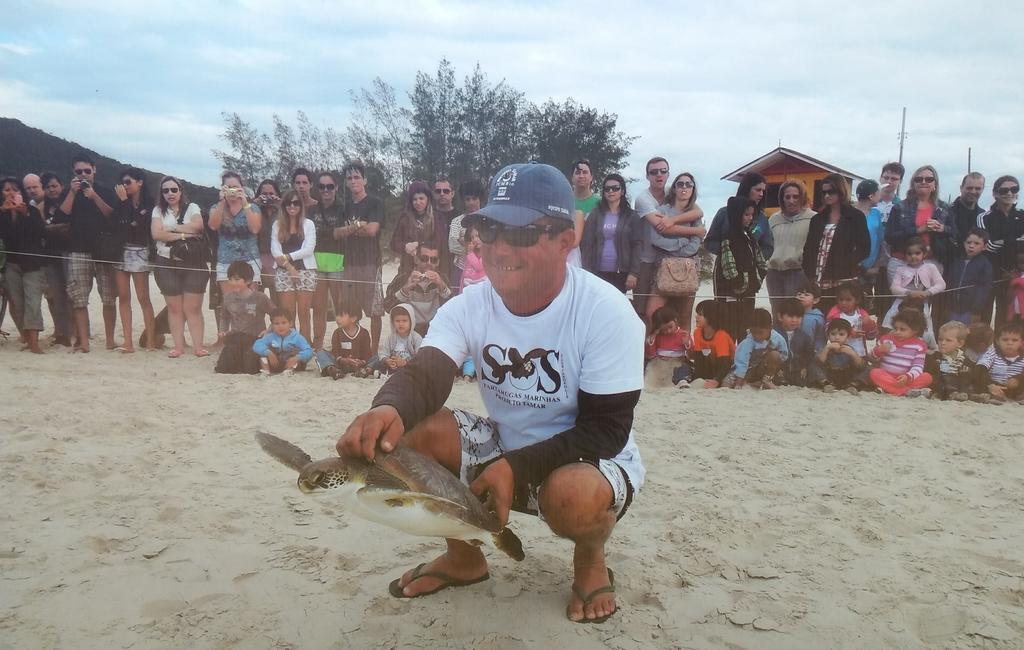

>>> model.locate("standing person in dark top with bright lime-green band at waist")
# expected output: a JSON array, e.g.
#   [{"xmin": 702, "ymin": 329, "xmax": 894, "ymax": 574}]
[{"xmin": 309, "ymin": 172, "xmax": 345, "ymax": 350}]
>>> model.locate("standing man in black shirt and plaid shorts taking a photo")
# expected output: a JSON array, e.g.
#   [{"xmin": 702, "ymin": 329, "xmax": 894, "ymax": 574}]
[{"xmin": 59, "ymin": 154, "xmax": 118, "ymax": 352}]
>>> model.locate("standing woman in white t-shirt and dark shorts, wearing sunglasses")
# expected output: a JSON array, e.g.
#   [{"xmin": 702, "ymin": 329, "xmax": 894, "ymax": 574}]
[{"xmin": 151, "ymin": 176, "xmax": 210, "ymax": 359}]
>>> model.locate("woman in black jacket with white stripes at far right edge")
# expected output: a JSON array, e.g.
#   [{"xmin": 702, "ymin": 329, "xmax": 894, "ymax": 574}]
[{"xmin": 978, "ymin": 175, "xmax": 1024, "ymax": 322}]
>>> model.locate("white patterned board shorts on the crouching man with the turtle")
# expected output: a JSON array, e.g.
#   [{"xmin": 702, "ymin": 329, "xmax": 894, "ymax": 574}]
[{"xmin": 452, "ymin": 408, "xmax": 633, "ymax": 521}]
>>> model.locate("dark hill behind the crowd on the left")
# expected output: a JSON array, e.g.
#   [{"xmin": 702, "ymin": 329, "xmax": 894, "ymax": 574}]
[{"xmin": 0, "ymin": 118, "xmax": 217, "ymax": 206}]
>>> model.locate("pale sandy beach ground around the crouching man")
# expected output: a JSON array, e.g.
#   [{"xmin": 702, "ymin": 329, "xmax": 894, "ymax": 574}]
[{"xmin": 0, "ymin": 280, "xmax": 1024, "ymax": 650}]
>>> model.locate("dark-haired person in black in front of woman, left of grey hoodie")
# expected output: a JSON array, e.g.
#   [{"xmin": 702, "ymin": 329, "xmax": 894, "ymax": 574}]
[{"xmin": 715, "ymin": 197, "xmax": 768, "ymax": 341}]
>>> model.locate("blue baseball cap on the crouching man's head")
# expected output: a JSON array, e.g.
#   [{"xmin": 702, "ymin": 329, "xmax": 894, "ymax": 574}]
[{"xmin": 471, "ymin": 163, "xmax": 575, "ymax": 227}]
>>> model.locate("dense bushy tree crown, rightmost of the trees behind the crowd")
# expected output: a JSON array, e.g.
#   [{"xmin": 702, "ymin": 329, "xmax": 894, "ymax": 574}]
[{"xmin": 527, "ymin": 98, "xmax": 636, "ymax": 182}]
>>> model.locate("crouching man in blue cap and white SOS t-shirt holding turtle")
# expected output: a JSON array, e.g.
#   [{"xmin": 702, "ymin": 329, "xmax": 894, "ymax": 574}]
[{"xmin": 337, "ymin": 164, "xmax": 645, "ymax": 622}]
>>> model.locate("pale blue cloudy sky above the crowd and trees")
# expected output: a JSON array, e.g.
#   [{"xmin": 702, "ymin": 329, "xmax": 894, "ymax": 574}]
[{"xmin": 0, "ymin": 0, "xmax": 1024, "ymax": 213}]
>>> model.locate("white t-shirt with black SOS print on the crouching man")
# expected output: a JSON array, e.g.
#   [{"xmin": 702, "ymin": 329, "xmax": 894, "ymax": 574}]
[{"xmin": 423, "ymin": 265, "xmax": 646, "ymax": 489}]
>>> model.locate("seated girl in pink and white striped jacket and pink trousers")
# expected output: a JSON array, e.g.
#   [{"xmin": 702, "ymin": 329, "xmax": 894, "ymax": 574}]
[{"xmin": 869, "ymin": 309, "xmax": 932, "ymax": 397}]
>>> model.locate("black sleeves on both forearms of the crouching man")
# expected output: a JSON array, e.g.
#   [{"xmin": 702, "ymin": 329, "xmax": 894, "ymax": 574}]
[{"xmin": 373, "ymin": 347, "xmax": 640, "ymax": 485}]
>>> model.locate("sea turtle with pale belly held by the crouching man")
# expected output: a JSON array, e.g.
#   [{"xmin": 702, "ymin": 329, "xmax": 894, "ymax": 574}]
[{"xmin": 256, "ymin": 433, "xmax": 524, "ymax": 560}]
